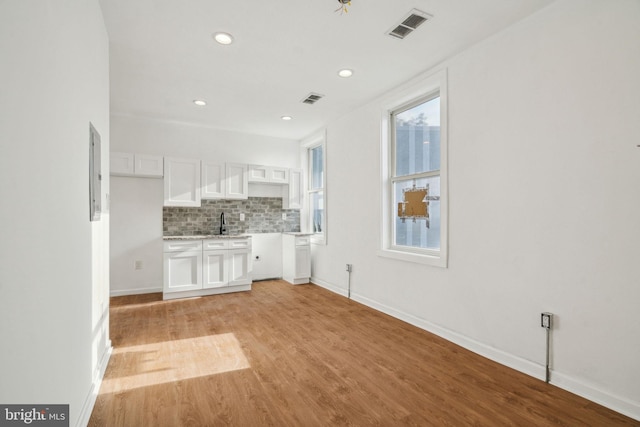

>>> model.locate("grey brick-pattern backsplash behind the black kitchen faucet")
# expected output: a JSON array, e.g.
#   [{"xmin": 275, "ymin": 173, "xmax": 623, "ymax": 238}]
[{"xmin": 162, "ymin": 197, "xmax": 300, "ymax": 236}]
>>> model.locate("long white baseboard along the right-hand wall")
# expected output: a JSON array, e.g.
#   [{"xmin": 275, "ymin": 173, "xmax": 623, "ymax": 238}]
[{"xmin": 311, "ymin": 278, "xmax": 640, "ymax": 421}]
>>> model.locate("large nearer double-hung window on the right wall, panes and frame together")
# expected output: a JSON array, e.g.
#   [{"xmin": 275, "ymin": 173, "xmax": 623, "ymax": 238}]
[{"xmin": 381, "ymin": 70, "xmax": 447, "ymax": 266}]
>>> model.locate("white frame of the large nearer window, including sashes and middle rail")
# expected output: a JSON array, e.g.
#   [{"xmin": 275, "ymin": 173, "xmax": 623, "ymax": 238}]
[{"xmin": 378, "ymin": 69, "xmax": 449, "ymax": 268}]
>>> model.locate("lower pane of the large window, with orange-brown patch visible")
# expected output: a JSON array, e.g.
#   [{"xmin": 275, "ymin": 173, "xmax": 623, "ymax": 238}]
[{"xmin": 393, "ymin": 176, "xmax": 440, "ymax": 250}]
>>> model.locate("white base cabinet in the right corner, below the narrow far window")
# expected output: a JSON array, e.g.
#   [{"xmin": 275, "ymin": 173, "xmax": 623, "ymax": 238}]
[{"xmin": 282, "ymin": 233, "xmax": 311, "ymax": 285}]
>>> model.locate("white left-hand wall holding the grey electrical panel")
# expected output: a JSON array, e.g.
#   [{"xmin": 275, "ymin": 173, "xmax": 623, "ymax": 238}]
[{"xmin": 0, "ymin": 0, "xmax": 110, "ymax": 425}]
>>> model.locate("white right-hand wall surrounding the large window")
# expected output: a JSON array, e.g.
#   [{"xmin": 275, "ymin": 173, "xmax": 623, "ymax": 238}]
[{"xmin": 313, "ymin": 0, "xmax": 640, "ymax": 419}]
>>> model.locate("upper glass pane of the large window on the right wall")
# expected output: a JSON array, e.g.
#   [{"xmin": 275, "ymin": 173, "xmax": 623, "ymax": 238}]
[{"xmin": 394, "ymin": 97, "xmax": 440, "ymax": 176}]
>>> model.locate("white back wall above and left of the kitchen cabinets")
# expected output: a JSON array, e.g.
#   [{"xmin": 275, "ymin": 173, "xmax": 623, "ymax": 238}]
[{"xmin": 111, "ymin": 115, "xmax": 300, "ymax": 295}]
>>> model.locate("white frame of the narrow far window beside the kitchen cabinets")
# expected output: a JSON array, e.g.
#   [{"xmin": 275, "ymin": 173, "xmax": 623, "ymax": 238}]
[{"xmin": 301, "ymin": 131, "xmax": 329, "ymax": 245}]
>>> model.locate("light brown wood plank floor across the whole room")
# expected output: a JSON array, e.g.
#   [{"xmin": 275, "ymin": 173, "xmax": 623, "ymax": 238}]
[{"xmin": 89, "ymin": 281, "xmax": 640, "ymax": 427}]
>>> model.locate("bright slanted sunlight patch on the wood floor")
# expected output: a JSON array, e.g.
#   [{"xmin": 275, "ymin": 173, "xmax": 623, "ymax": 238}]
[{"xmin": 100, "ymin": 333, "xmax": 250, "ymax": 394}]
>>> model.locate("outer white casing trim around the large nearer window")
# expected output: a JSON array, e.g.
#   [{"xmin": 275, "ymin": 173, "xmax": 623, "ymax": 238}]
[{"xmin": 378, "ymin": 68, "xmax": 449, "ymax": 268}]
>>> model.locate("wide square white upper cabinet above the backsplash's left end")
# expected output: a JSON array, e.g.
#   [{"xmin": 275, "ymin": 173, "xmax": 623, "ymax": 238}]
[{"xmin": 164, "ymin": 157, "xmax": 201, "ymax": 207}]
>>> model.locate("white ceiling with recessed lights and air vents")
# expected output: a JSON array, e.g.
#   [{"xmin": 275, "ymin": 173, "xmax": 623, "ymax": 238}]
[{"xmin": 100, "ymin": 0, "xmax": 553, "ymax": 139}]
